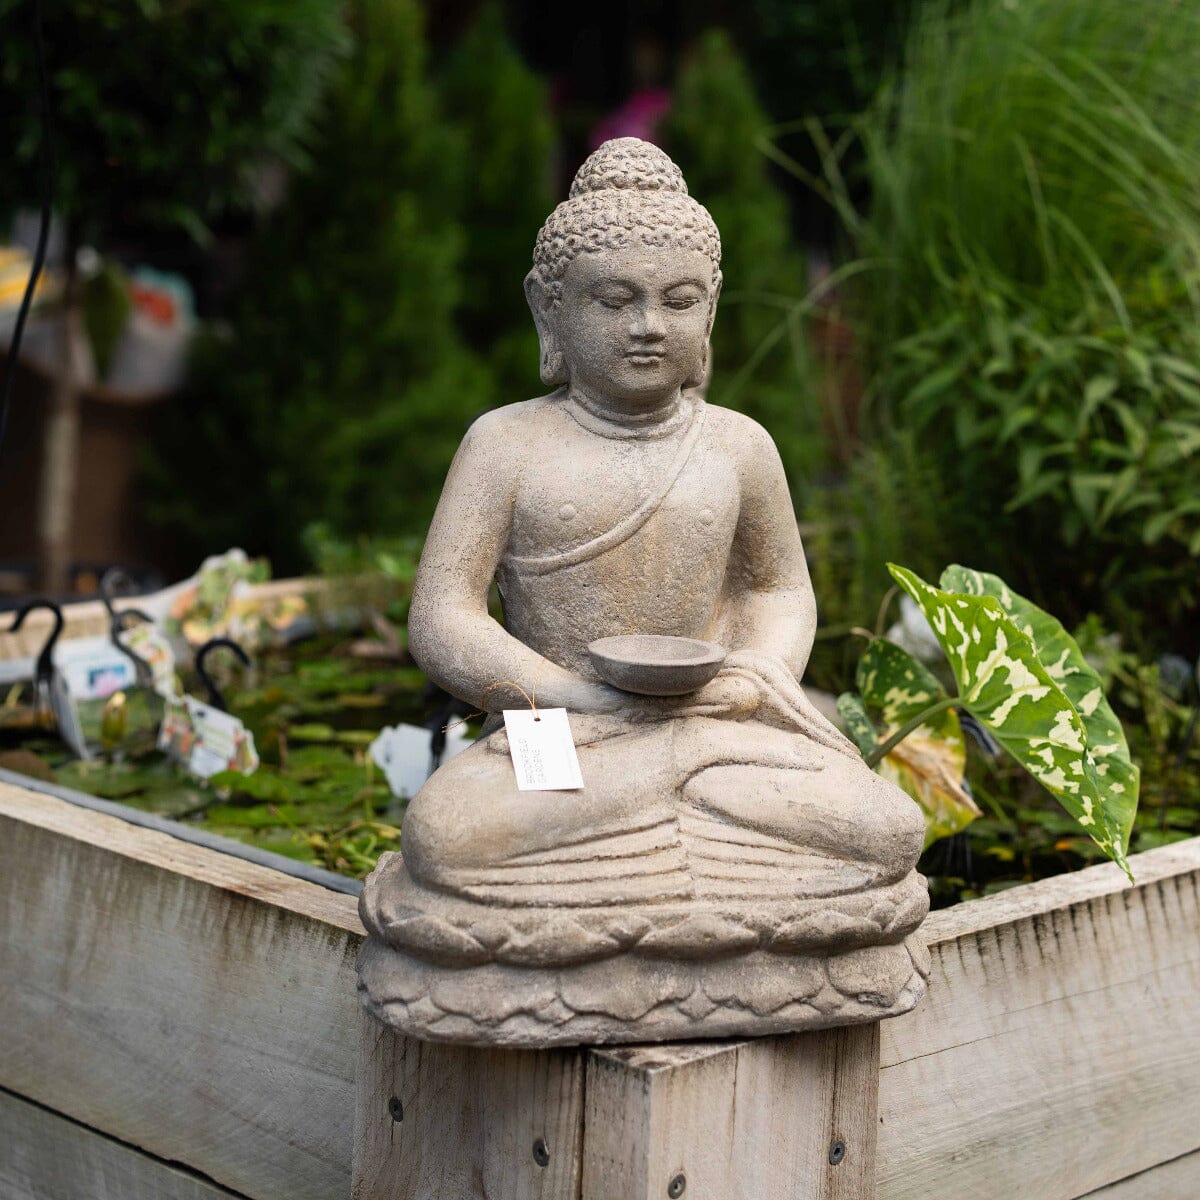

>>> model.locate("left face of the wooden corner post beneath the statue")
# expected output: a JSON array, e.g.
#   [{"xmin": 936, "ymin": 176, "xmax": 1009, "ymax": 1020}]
[{"xmin": 353, "ymin": 1013, "xmax": 583, "ymax": 1200}]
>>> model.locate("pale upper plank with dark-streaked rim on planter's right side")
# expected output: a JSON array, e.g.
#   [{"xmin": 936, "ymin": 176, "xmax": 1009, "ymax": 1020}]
[{"xmin": 878, "ymin": 839, "xmax": 1200, "ymax": 1200}]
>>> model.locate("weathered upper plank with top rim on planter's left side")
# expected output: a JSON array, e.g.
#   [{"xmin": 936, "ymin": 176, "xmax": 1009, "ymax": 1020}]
[{"xmin": 0, "ymin": 785, "xmax": 361, "ymax": 1200}]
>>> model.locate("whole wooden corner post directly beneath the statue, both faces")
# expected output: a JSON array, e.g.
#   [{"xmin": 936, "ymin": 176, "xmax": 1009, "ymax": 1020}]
[{"xmin": 353, "ymin": 1014, "xmax": 880, "ymax": 1200}]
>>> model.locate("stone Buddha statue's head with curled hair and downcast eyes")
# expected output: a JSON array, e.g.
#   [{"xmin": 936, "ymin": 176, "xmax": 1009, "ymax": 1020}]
[{"xmin": 526, "ymin": 138, "xmax": 721, "ymax": 407}]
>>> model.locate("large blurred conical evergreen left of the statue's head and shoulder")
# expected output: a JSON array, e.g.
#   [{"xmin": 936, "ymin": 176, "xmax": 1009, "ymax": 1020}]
[{"xmin": 151, "ymin": 0, "xmax": 494, "ymax": 571}]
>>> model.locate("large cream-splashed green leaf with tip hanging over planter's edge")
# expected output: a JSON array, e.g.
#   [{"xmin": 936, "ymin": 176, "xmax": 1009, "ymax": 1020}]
[{"xmin": 888, "ymin": 564, "xmax": 1136, "ymax": 874}]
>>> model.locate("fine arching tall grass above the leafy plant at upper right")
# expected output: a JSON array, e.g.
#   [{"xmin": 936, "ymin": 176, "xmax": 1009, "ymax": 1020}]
[{"xmin": 842, "ymin": 0, "xmax": 1200, "ymax": 337}]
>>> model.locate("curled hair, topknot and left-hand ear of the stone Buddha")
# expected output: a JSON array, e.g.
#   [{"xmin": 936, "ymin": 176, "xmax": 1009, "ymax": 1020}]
[{"xmin": 526, "ymin": 138, "xmax": 721, "ymax": 384}]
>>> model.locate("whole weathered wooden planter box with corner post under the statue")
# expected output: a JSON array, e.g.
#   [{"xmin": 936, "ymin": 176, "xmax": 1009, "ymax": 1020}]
[{"xmin": 0, "ymin": 775, "xmax": 1200, "ymax": 1200}]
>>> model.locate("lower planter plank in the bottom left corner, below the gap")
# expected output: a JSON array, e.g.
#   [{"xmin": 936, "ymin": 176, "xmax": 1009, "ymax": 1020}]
[{"xmin": 0, "ymin": 1092, "xmax": 239, "ymax": 1200}]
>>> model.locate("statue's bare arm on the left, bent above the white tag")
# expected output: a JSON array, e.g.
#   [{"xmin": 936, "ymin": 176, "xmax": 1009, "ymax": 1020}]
[{"xmin": 408, "ymin": 409, "xmax": 629, "ymax": 713}]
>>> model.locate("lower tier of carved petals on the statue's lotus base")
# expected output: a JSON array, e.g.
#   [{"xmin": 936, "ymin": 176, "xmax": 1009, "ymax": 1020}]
[{"xmin": 359, "ymin": 935, "xmax": 929, "ymax": 1046}]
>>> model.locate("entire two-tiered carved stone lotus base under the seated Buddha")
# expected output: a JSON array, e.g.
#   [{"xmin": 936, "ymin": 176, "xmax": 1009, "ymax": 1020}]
[{"xmin": 359, "ymin": 854, "xmax": 929, "ymax": 1046}]
